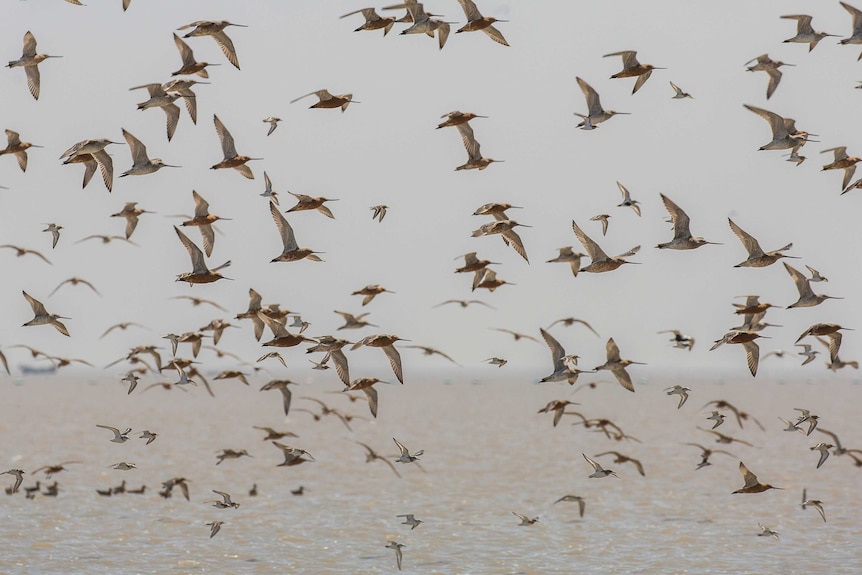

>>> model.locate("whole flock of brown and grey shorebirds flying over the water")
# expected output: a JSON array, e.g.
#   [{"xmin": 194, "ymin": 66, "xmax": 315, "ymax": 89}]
[{"xmin": 0, "ymin": 0, "xmax": 862, "ymax": 570}]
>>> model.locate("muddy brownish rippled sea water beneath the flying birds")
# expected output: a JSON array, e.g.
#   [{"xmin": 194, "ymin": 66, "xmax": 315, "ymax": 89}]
[{"xmin": 0, "ymin": 372, "xmax": 862, "ymax": 575}]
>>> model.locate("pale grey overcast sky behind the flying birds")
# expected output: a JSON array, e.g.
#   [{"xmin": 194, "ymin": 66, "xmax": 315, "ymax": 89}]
[{"xmin": 0, "ymin": 0, "xmax": 862, "ymax": 381}]
